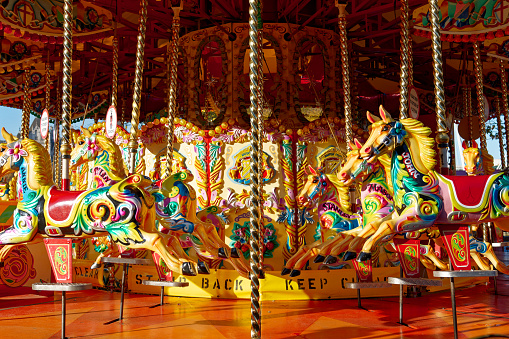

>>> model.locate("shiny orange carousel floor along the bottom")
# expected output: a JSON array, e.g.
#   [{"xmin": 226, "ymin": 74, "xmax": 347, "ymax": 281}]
[{"xmin": 0, "ymin": 285, "xmax": 509, "ymax": 339}]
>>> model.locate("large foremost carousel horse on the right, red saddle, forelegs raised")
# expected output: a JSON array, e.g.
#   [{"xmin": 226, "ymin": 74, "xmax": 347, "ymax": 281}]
[{"xmin": 348, "ymin": 107, "xmax": 509, "ymax": 268}]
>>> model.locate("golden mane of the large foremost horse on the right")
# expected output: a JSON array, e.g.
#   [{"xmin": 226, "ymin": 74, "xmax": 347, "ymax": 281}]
[{"xmin": 400, "ymin": 118, "xmax": 436, "ymax": 171}]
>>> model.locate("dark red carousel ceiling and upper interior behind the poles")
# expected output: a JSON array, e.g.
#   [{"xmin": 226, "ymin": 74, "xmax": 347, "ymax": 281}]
[{"xmin": 0, "ymin": 0, "xmax": 509, "ymax": 129}]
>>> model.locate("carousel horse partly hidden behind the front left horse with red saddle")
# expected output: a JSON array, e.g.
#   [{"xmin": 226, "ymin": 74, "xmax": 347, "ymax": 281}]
[{"xmin": 71, "ymin": 128, "xmax": 249, "ymax": 276}]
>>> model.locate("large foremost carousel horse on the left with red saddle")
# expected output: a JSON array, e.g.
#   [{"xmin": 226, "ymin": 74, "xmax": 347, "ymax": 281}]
[{"xmin": 0, "ymin": 129, "xmax": 196, "ymax": 275}]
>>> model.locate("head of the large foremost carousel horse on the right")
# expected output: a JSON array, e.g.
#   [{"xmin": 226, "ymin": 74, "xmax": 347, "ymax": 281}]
[{"xmin": 360, "ymin": 105, "xmax": 406, "ymax": 162}]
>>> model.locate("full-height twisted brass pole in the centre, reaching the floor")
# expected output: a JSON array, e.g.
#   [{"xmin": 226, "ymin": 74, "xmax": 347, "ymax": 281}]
[{"xmin": 249, "ymin": 0, "xmax": 263, "ymax": 338}]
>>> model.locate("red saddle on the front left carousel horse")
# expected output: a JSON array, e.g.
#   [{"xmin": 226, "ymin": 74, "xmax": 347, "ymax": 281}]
[{"xmin": 46, "ymin": 186, "xmax": 86, "ymax": 227}]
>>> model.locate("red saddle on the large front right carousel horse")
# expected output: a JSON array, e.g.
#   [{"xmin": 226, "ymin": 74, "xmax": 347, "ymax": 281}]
[{"xmin": 444, "ymin": 174, "xmax": 498, "ymax": 210}]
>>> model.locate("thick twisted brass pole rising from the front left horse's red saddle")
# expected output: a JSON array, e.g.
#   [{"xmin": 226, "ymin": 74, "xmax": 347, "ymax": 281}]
[{"xmin": 60, "ymin": 0, "xmax": 73, "ymax": 190}]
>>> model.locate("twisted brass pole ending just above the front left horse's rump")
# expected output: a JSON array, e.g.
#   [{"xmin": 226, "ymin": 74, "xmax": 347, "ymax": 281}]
[{"xmin": 129, "ymin": 0, "xmax": 148, "ymax": 173}]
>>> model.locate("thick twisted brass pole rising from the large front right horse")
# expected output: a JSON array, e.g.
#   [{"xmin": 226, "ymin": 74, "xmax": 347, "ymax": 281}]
[{"xmin": 429, "ymin": 0, "xmax": 449, "ymax": 168}]
